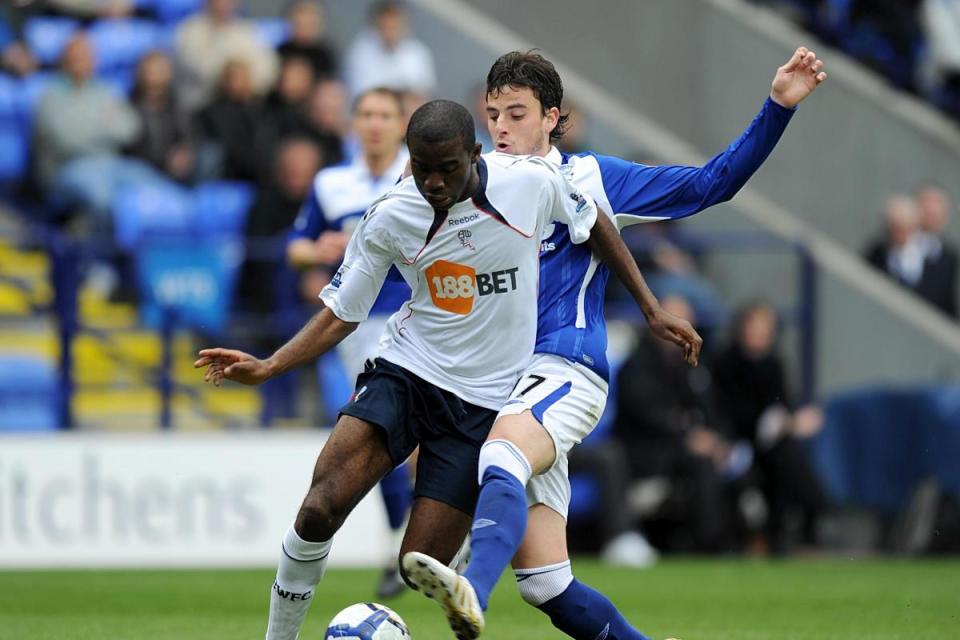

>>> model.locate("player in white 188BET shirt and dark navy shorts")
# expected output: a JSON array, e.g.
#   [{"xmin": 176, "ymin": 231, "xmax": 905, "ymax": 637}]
[{"xmin": 195, "ymin": 100, "xmax": 676, "ymax": 640}]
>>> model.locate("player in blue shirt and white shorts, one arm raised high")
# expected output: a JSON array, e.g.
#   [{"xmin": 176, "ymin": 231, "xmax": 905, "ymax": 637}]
[{"xmin": 403, "ymin": 47, "xmax": 826, "ymax": 640}]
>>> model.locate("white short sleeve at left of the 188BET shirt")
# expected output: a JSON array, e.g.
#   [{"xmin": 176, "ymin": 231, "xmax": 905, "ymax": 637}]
[{"xmin": 320, "ymin": 205, "xmax": 396, "ymax": 322}]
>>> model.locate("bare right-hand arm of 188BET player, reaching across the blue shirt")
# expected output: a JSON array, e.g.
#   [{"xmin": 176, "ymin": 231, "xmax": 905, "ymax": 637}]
[{"xmin": 588, "ymin": 212, "xmax": 703, "ymax": 367}]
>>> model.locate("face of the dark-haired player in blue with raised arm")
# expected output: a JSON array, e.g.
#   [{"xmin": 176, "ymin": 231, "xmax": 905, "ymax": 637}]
[{"xmin": 487, "ymin": 86, "xmax": 560, "ymax": 156}]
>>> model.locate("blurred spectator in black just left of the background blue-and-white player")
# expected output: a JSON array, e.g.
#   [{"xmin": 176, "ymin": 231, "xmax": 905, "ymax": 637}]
[{"xmin": 238, "ymin": 138, "xmax": 320, "ymax": 313}]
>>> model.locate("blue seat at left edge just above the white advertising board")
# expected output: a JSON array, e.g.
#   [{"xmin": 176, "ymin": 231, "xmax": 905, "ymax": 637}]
[{"xmin": 0, "ymin": 354, "xmax": 59, "ymax": 432}]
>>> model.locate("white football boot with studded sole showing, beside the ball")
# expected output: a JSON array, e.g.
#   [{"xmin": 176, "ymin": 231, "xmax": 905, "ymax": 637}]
[{"xmin": 403, "ymin": 551, "xmax": 483, "ymax": 640}]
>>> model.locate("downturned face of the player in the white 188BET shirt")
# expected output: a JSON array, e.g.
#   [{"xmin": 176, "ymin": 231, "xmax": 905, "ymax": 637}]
[{"xmin": 409, "ymin": 138, "xmax": 480, "ymax": 210}]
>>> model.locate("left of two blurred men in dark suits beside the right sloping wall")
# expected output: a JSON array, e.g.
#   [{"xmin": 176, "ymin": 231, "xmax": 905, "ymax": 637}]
[{"xmin": 866, "ymin": 195, "xmax": 926, "ymax": 291}]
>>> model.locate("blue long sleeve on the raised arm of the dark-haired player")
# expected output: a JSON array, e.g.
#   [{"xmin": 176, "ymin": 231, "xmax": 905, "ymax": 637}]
[{"xmin": 595, "ymin": 98, "xmax": 794, "ymax": 222}]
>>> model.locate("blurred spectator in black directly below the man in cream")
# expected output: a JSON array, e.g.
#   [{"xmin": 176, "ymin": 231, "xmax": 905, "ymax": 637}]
[{"xmin": 198, "ymin": 60, "xmax": 261, "ymax": 181}]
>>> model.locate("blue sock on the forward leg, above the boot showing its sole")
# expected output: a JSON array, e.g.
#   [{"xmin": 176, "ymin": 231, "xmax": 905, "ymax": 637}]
[{"xmin": 463, "ymin": 466, "xmax": 528, "ymax": 608}]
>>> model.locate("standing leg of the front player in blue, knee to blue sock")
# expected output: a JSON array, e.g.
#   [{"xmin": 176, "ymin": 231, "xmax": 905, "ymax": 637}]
[{"xmin": 513, "ymin": 504, "xmax": 648, "ymax": 640}]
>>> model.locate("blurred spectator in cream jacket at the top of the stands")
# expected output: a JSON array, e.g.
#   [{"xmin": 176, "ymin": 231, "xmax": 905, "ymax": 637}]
[{"xmin": 175, "ymin": 0, "xmax": 277, "ymax": 111}]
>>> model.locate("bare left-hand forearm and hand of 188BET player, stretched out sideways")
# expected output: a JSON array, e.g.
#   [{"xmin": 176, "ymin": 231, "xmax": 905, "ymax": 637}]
[{"xmin": 193, "ymin": 309, "xmax": 357, "ymax": 387}]
